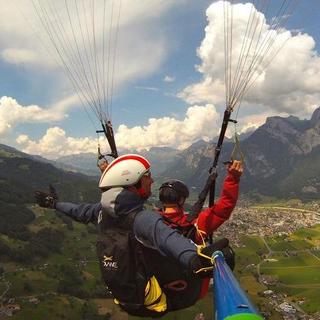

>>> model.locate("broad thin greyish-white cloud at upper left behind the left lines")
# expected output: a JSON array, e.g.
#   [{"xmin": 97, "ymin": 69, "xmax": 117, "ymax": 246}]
[{"xmin": 0, "ymin": 0, "xmax": 185, "ymax": 91}]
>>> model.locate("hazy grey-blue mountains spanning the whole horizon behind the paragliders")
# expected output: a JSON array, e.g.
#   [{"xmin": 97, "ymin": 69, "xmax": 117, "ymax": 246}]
[{"xmin": 0, "ymin": 107, "xmax": 320, "ymax": 200}]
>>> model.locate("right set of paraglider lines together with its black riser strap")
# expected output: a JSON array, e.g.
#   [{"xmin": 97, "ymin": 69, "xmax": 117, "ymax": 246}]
[{"xmin": 193, "ymin": 0, "xmax": 298, "ymax": 212}]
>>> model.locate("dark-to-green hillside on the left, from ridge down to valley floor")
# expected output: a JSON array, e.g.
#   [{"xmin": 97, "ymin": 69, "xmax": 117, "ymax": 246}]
[{"xmin": 0, "ymin": 145, "xmax": 105, "ymax": 319}]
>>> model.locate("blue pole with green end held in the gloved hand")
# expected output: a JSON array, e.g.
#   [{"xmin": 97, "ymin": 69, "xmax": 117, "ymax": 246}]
[{"xmin": 212, "ymin": 251, "xmax": 263, "ymax": 320}]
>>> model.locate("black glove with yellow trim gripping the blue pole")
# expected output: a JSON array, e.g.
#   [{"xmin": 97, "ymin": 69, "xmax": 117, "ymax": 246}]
[{"xmin": 190, "ymin": 238, "xmax": 234, "ymax": 278}]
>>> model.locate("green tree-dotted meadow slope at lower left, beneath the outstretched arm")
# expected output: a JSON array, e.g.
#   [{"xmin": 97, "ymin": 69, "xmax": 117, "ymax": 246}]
[{"xmin": 0, "ymin": 206, "xmax": 212, "ymax": 320}]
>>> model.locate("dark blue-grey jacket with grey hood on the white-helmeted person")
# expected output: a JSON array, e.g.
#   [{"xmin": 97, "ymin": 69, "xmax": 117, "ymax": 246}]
[{"xmin": 56, "ymin": 188, "xmax": 197, "ymax": 269}]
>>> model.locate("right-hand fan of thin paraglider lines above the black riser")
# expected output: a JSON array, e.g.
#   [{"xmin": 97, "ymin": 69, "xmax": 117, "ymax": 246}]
[{"xmin": 219, "ymin": 0, "xmax": 298, "ymax": 111}]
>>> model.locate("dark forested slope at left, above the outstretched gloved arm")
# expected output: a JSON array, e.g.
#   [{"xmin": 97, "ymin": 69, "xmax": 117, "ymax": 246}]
[{"xmin": 0, "ymin": 144, "xmax": 99, "ymax": 204}]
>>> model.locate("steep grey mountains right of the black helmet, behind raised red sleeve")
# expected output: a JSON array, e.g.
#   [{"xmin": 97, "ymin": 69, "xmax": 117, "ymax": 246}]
[{"xmin": 161, "ymin": 108, "xmax": 320, "ymax": 199}]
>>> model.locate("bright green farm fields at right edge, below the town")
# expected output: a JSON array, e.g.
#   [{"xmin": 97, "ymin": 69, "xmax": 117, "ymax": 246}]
[{"xmin": 260, "ymin": 225, "xmax": 320, "ymax": 313}]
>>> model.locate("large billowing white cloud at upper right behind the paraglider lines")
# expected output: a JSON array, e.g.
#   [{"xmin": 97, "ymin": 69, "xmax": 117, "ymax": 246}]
[{"xmin": 179, "ymin": 1, "xmax": 320, "ymax": 116}]
